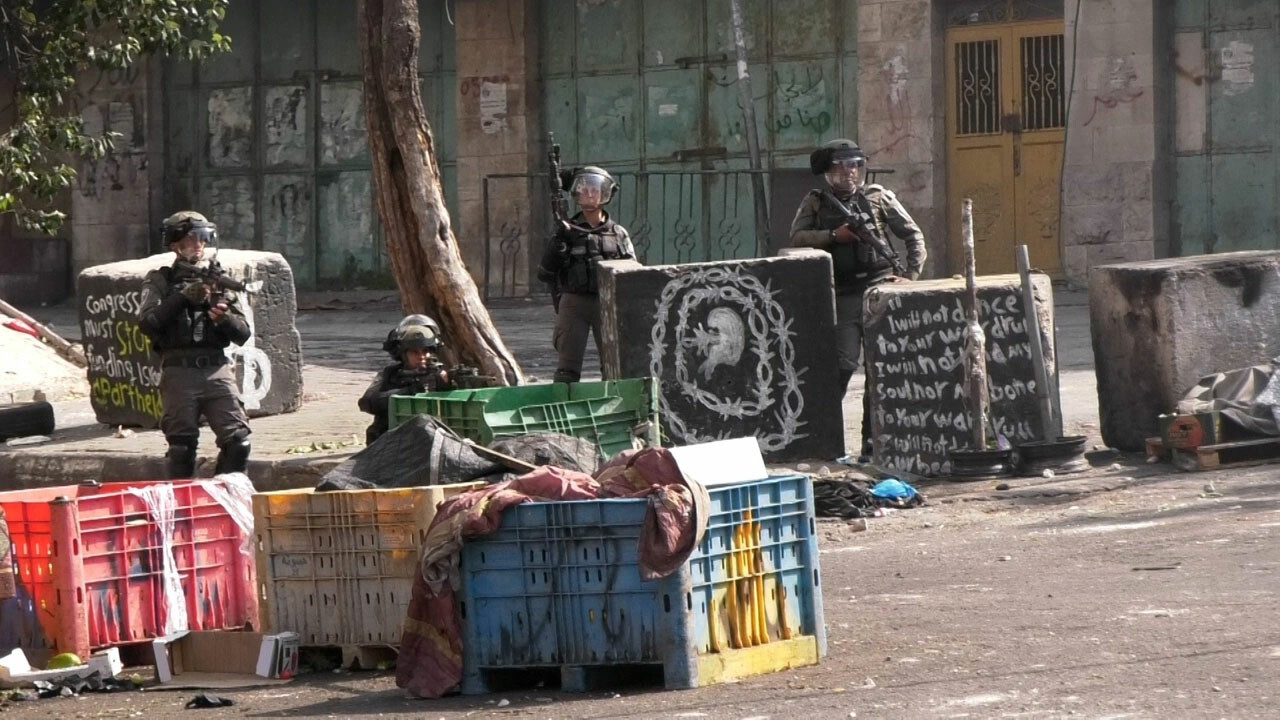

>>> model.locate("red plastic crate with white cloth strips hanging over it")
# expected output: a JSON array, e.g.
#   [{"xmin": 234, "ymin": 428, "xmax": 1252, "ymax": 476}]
[{"xmin": 0, "ymin": 480, "xmax": 259, "ymax": 657}]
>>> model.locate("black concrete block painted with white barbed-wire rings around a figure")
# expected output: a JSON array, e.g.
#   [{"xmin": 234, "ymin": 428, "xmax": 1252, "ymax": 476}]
[{"xmin": 600, "ymin": 251, "xmax": 845, "ymax": 461}]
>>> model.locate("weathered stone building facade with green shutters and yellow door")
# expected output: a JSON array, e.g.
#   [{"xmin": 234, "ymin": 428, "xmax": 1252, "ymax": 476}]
[{"xmin": 0, "ymin": 0, "xmax": 1280, "ymax": 302}]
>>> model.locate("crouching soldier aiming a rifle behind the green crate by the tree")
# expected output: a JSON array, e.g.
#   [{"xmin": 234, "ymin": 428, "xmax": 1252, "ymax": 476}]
[{"xmin": 357, "ymin": 315, "xmax": 454, "ymax": 445}]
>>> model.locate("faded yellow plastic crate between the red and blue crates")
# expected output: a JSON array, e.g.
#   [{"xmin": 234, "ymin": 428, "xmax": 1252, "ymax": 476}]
[{"xmin": 253, "ymin": 482, "xmax": 485, "ymax": 647}]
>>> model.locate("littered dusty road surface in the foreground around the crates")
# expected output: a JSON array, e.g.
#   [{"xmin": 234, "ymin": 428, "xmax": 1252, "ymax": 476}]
[{"xmin": 5, "ymin": 460, "xmax": 1280, "ymax": 720}]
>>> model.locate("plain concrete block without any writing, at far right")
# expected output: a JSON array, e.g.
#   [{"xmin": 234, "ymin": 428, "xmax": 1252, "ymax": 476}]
[{"xmin": 1089, "ymin": 252, "xmax": 1280, "ymax": 451}]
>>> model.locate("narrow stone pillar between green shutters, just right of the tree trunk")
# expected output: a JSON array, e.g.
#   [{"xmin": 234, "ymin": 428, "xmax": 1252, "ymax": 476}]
[{"xmin": 454, "ymin": 0, "xmax": 544, "ymax": 292}]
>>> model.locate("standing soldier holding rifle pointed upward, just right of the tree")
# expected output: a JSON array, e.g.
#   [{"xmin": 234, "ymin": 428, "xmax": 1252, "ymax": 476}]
[{"xmin": 538, "ymin": 165, "xmax": 636, "ymax": 383}]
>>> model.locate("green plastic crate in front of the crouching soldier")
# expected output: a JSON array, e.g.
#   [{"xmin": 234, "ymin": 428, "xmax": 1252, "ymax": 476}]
[{"xmin": 388, "ymin": 378, "xmax": 658, "ymax": 457}]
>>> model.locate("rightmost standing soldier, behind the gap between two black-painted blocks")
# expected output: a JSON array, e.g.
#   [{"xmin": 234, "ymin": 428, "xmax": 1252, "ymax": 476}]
[{"xmin": 791, "ymin": 140, "xmax": 927, "ymax": 456}]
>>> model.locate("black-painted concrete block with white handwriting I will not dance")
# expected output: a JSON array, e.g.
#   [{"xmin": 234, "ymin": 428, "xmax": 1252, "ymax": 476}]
[{"xmin": 863, "ymin": 273, "xmax": 1056, "ymax": 477}]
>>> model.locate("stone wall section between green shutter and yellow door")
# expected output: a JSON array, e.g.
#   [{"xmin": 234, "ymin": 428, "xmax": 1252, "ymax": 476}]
[{"xmin": 858, "ymin": 0, "xmax": 948, "ymax": 277}]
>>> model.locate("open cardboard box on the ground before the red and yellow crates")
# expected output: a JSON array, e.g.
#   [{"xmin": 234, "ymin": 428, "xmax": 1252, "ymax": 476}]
[{"xmin": 151, "ymin": 630, "xmax": 298, "ymax": 688}]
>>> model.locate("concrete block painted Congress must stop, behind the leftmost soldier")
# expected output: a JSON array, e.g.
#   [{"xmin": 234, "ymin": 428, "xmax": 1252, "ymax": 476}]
[{"xmin": 77, "ymin": 250, "xmax": 302, "ymax": 428}]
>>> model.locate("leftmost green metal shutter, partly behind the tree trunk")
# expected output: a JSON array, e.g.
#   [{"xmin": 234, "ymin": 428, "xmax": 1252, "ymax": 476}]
[{"xmin": 164, "ymin": 0, "xmax": 457, "ymax": 290}]
